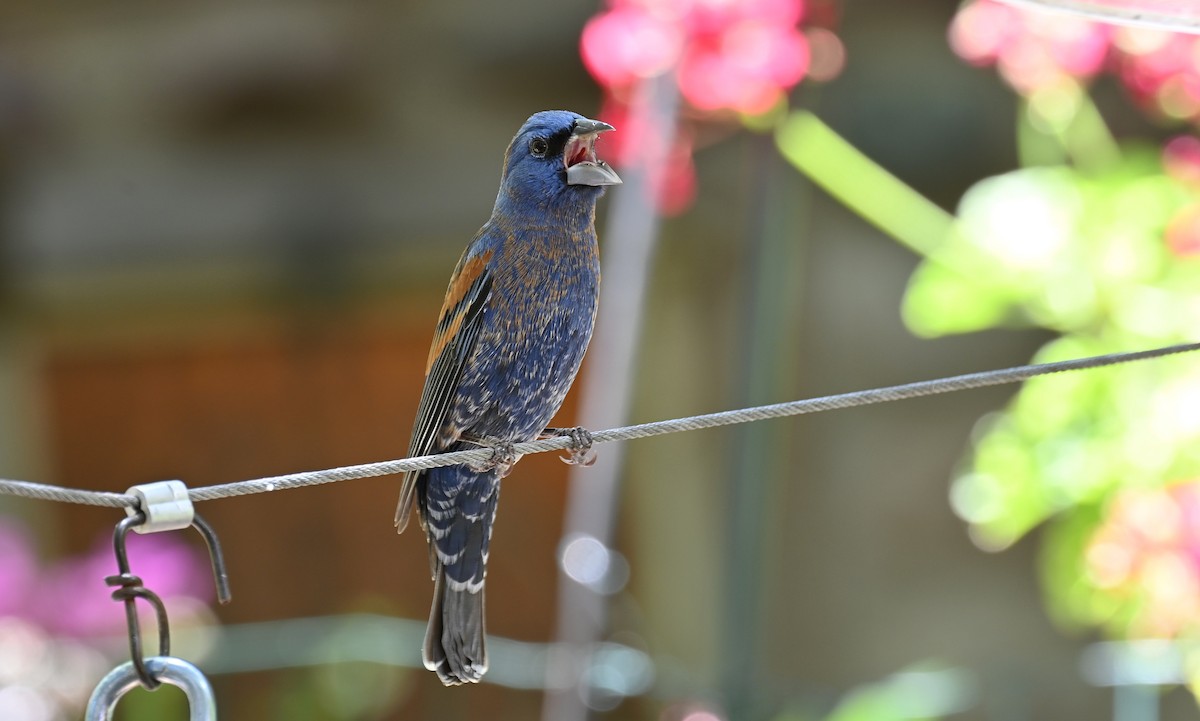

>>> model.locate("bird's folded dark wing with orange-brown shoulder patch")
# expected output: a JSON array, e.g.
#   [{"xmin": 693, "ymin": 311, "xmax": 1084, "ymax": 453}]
[{"xmin": 396, "ymin": 244, "xmax": 493, "ymax": 533}]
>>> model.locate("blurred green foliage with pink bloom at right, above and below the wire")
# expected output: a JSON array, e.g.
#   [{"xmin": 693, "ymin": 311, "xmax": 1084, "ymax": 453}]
[{"xmin": 904, "ymin": 94, "xmax": 1200, "ymax": 637}]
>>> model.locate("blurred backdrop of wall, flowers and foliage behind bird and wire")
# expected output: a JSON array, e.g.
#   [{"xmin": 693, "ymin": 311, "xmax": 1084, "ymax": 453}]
[{"xmin": 0, "ymin": 0, "xmax": 1200, "ymax": 721}]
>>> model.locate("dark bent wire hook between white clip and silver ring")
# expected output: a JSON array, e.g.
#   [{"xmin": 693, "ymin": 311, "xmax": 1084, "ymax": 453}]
[{"xmin": 104, "ymin": 481, "xmax": 232, "ymax": 691}]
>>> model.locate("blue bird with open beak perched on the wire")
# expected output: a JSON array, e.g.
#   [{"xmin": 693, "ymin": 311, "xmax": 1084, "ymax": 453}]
[{"xmin": 395, "ymin": 110, "xmax": 620, "ymax": 686}]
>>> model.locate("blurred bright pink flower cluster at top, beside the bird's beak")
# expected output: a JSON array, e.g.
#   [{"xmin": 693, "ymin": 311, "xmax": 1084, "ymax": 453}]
[{"xmin": 580, "ymin": 0, "xmax": 845, "ymax": 215}]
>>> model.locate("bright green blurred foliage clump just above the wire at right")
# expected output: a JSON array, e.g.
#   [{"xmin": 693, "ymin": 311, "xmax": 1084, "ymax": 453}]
[{"xmin": 904, "ymin": 151, "xmax": 1200, "ymax": 347}]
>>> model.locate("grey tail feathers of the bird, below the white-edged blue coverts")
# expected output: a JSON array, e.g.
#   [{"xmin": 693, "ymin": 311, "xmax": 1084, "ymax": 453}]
[{"xmin": 421, "ymin": 561, "xmax": 487, "ymax": 686}]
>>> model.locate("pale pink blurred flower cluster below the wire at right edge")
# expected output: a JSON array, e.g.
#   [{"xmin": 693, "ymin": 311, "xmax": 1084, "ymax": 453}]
[{"xmin": 1086, "ymin": 481, "xmax": 1200, "ymax": 638}]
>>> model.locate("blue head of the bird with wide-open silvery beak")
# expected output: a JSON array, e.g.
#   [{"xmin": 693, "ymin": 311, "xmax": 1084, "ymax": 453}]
[{"xmin": 497, "ymin": 110, "xmax": 620, "ymax": 209}]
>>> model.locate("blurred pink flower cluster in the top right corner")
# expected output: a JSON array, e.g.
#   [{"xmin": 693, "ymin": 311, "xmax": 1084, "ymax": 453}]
[{"xmin": 949, "ymin": 0, "xmax": 1200, "ymax": 122}]
